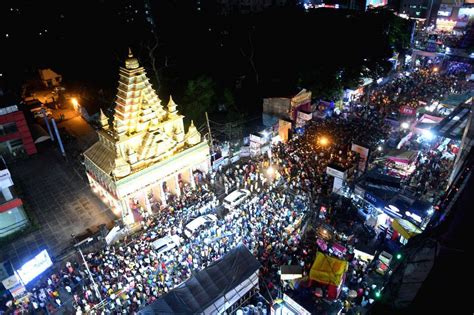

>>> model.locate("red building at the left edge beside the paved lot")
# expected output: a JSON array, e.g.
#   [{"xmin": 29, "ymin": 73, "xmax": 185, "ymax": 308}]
[{"xmin": 0, "ymin": 105, "xmax": 37, "ymax": 160}]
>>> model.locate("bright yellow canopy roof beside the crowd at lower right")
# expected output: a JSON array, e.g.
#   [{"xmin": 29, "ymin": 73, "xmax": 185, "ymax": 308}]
[{"xmin": 309, "ymin": 252, "xmax": 348, "ymax": 286}]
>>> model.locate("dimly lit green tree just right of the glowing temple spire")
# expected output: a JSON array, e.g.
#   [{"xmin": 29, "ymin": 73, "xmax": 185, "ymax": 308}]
[{"xmin": 182, "ymin": 75, "xmax": 216, "ymax": 125}]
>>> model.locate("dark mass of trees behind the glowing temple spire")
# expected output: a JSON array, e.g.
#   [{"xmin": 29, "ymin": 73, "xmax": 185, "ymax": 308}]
[{"xmin": 2, "ymin": 0, "xmax": 410, "ymax": 118}]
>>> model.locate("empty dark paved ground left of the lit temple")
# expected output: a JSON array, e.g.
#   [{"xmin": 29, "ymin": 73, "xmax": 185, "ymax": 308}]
[{"xmin": 0, "ymin": 144, "xmax": 115, "ymax": 267}]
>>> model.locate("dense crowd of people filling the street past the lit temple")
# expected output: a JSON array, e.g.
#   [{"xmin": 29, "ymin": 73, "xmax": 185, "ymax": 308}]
[{"xmin": 2, "ymin": 54, "xmax": 465, "ymax": 314}]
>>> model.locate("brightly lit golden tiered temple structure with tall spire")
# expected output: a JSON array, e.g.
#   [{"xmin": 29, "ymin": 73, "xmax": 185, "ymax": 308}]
[{"xmin": 84, "ymin": 52, "xmax": 210, "ymax": 224}]
